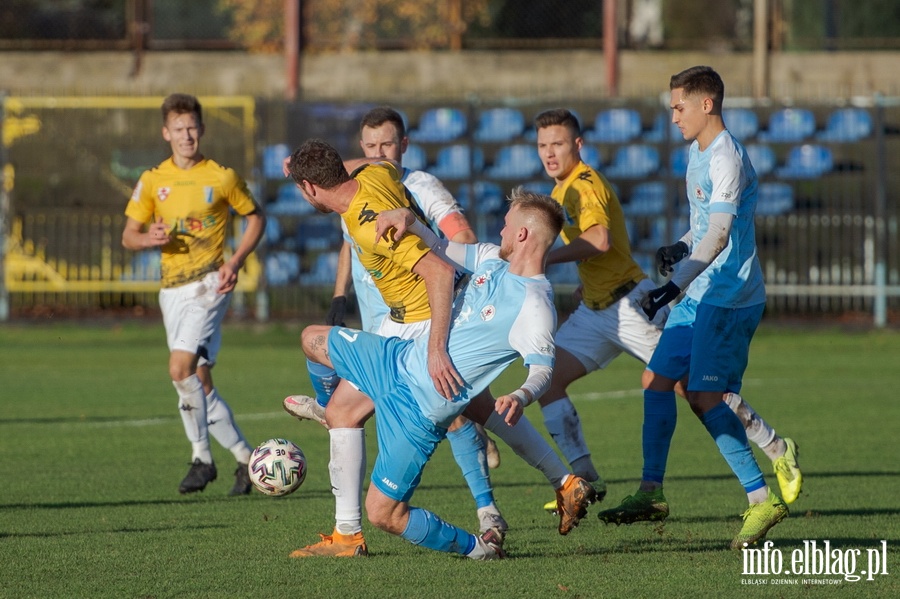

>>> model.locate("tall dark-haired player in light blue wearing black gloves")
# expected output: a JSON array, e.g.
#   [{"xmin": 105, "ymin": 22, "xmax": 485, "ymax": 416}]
[{"xmin": 600, "ymin": 66, "xmax": 788, "ymax": 549}]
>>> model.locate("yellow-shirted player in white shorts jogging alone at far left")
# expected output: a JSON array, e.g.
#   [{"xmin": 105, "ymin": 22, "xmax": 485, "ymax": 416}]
[{"xmin": 122, "ymin": 94, "xmax": 266, "ymax": 495}]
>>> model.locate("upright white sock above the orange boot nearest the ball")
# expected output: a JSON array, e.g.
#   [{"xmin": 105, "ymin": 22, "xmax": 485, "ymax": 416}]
[{"xmin": 328, "ymin": 428, "xmax": 366, "ymax": 535}]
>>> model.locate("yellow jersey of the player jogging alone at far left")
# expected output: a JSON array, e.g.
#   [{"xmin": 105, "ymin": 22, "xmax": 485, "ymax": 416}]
[{"xmin": 125, "ymin": 157, "xmax": 257, "ymax": 287}]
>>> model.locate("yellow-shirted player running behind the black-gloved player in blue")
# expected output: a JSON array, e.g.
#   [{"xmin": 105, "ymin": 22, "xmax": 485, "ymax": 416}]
[{"xmin": 535, "ymin": 109, "xmax": 800, "ymax": 522}]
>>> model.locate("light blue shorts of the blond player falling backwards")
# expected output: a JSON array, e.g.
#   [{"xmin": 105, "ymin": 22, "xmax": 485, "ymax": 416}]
[{"xmin": 328, "ymin": 327, "xmax": 447, "ymax": 502}]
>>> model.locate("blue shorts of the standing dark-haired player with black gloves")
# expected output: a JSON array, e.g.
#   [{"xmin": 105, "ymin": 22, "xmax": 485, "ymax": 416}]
[{"xmin": 647, "ymin": 297, "xmax": 765, "ymax": 393}]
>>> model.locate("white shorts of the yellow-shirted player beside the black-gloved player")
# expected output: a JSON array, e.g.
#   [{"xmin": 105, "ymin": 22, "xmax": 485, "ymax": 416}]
[{"xmin": 556, "ymin": 279, "xmax": 669, "ymax": 372}]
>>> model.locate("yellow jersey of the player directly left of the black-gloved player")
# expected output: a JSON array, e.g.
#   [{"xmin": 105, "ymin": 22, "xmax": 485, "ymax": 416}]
[{"xmin": 551, "ymin": 162, "xmax": 647, "ymax": 310}]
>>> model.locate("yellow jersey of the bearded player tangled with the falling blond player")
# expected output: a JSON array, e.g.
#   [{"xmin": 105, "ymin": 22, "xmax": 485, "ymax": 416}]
[{"xmin": 341, "ymin": 162, "xmax": 431, "ymax": 324}]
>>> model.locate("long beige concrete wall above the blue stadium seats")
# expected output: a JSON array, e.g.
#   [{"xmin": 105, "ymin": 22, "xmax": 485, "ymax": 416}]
[{"xmin": 0, "ymin": 50, "xmax": 900, "ymax": 101}]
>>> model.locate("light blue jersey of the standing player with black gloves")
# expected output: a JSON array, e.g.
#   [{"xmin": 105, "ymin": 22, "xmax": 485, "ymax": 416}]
[{"xmin": 686, "ymin": 130, "xmax": 766, "ymax": 308}]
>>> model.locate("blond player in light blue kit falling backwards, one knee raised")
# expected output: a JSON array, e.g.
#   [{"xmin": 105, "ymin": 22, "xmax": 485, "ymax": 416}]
[{"xmin": 302, "ymin": 190, "xmax": 568, "ymax": 559}]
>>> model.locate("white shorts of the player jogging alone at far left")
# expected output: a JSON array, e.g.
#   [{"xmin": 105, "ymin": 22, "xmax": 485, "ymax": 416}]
[{"xmin": 159, "ymin": 271, "xmax": 231, "ymax": 366}]
